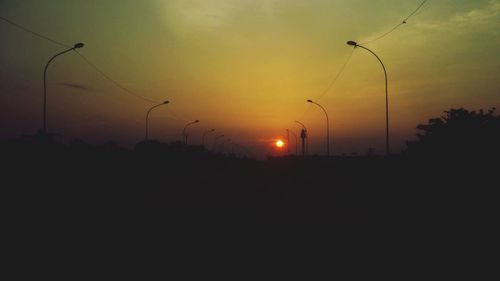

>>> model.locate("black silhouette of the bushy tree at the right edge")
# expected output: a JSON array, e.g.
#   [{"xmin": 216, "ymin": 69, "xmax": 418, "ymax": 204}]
[{"xmin": 405, "ymin": 108, "xmax": 500, "ymax": 157}]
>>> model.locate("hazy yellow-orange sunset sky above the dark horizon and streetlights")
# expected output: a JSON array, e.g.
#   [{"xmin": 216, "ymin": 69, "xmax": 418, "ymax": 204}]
[{"xmin": 0, "ymin": 0, "xmax": 500, "ymax": 155}]
